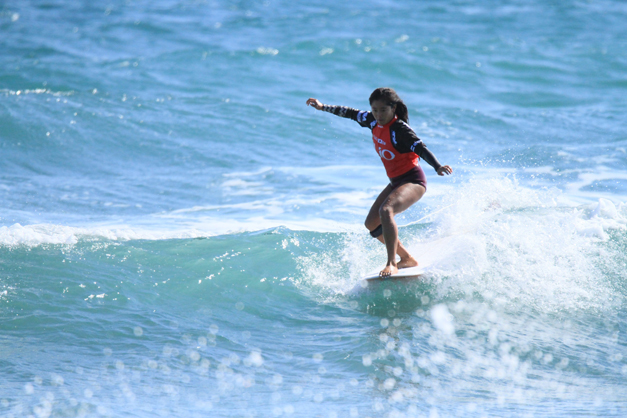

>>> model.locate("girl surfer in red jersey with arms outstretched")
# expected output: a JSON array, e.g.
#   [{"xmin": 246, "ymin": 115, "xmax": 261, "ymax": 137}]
[{"xmin": 307, "ymin": 87, "xmax": 453, "ymax": 277}]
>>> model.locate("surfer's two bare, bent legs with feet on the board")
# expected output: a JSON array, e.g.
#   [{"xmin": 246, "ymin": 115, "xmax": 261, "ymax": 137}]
[{"xmin": 365, "ymin": 184, "xmax": 425, "ymax": 275}]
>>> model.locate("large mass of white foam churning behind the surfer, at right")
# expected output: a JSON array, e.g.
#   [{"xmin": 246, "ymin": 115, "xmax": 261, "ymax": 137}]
[{"xmin": 410, "ymin": 179, "xmax": 627, "ymax": 311}]
